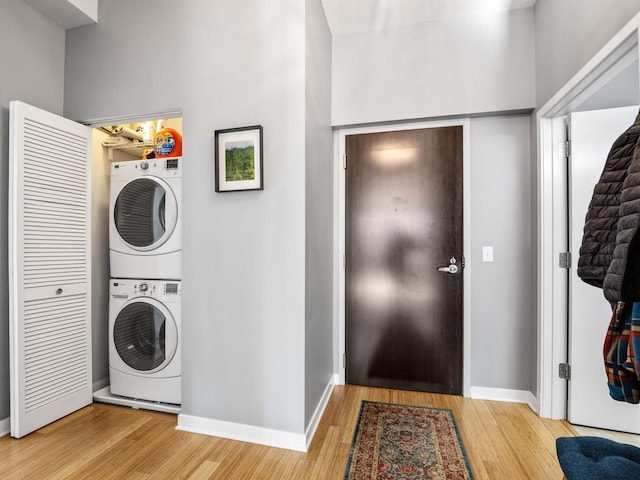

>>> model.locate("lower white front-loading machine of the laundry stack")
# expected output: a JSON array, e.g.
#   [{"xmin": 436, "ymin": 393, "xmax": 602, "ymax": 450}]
[{"xmin": 109, "ymin": 279, "xmax": 182, "ymax": 404}]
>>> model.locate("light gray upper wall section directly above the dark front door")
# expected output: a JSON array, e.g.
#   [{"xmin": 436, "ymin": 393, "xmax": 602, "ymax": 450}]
[{"xmin": 332, "ymin": 8, "xmax": 535, "ymax": 125}]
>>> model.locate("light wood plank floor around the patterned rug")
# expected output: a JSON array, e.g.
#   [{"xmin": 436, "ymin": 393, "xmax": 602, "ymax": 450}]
[{"xmin": 0, "ymin": 386, "xmax": 576, "ymax": 480}]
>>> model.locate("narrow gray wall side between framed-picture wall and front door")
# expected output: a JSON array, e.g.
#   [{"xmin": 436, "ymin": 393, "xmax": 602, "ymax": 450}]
[{"xmin": 305, "ymin": 0, "xmax": 334, "ymax": 425}]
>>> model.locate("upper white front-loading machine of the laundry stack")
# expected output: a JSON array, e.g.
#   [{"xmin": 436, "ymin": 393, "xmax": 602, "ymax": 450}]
[{"xmin": 109, "ymin": 157, "xmax": 182, "ymax": 279}]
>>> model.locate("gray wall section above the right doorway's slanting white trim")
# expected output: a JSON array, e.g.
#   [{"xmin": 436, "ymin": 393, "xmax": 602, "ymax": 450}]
[{"xmin": 534, "ymin": 0, "xmax": 640, "ymax": 107}]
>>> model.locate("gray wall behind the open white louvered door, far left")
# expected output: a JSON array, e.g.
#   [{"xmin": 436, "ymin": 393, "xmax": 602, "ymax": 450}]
[{"xmin": 0, "ymin": 0, "xmax": 64, "ymax": 420}]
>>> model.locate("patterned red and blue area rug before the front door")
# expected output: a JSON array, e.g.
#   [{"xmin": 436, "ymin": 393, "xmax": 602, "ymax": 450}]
[{"xmin": 344, "ymin": 401, "xmax": 473, "ymax": 480}]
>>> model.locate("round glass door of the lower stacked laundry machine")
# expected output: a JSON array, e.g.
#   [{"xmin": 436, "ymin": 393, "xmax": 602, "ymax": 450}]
[{"xmin": 113, "ymin": 297, "xmax": 178, "ymax": 373}]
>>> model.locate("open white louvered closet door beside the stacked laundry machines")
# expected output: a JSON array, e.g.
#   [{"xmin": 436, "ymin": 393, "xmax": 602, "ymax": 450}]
[{"xmin": 9, "ymin": 102, "xmax": 92, "ymax": 438}]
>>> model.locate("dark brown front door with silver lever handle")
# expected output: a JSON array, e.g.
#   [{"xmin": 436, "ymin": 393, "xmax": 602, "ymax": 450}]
[{"xmin": 345, "ymin": 126, "xmax": 463, "ymax": 394}]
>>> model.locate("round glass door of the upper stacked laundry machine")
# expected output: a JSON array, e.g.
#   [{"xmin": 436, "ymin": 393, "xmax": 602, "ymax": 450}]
[{"xmin": 113, "ymin": 176, "xmax": 178, "ymax": 251}]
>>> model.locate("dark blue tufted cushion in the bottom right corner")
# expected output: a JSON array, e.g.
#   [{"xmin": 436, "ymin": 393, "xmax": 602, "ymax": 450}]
[{"xmin": 556, "ymin": 437, "xmax": 640, "ymax": 480}]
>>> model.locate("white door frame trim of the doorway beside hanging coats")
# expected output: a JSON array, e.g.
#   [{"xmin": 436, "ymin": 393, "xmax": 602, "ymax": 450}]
[{"xmin": 536, "ymin": 14, "xmax": 640, "ymax": 419}]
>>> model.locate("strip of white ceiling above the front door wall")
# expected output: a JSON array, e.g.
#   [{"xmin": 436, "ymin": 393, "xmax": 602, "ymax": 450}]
[{"xmin": 322, "ymin": 0, "xmax": 536, "ymax": 35}]
